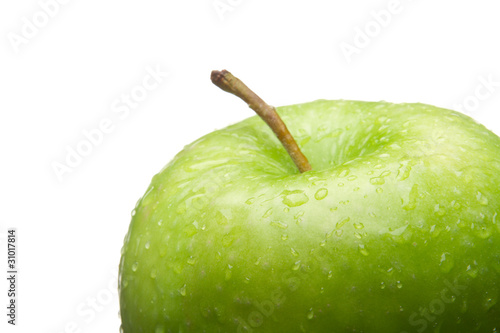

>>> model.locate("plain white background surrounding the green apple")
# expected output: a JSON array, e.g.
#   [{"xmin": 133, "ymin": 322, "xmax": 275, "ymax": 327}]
[{"xmin": 0, "ymin": 0, "xmax": 500, "ymax": 333}]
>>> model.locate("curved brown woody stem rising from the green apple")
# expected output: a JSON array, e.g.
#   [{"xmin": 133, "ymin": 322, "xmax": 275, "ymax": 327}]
[{"xmin": 210, "ymin": 69, "xmax": 311, "ymax": 172}]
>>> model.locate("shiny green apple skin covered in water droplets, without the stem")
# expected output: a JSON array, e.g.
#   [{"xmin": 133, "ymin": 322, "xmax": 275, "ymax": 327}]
[{"xmin": 119, "ymin": 100, "xmax": 500, "ymax": 333}]
